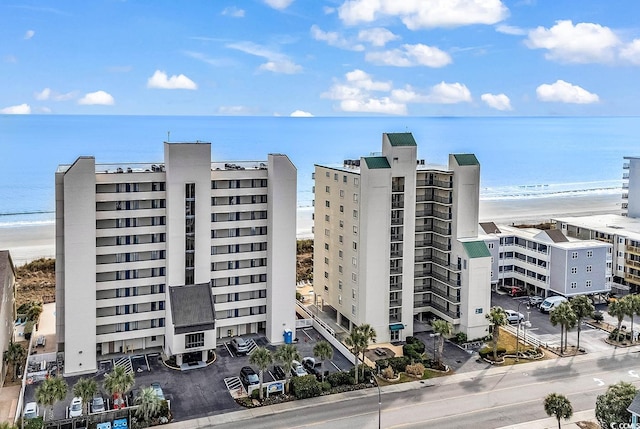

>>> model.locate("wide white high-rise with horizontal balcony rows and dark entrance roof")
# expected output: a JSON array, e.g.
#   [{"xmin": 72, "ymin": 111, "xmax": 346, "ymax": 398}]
[{"xmin": 56, "ymin": 142, "xmax": 296, "ymax": 375}]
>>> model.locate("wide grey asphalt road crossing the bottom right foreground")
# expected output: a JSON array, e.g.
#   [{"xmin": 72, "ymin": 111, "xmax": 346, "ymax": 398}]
[{"xmin": 186, "ymin": 349, "xmax": 640, "ymax": 429}]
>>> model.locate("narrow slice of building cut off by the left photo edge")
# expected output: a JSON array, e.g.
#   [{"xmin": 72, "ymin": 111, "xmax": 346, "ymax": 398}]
[{"xmin": 0, "ymin": 250, "xmax": 16, "ymax": 386}]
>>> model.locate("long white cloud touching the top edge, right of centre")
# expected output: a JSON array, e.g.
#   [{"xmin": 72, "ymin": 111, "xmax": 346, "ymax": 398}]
[{"xmin": 338, "ymin": 0, "xmax": 509, "ymax": 30}]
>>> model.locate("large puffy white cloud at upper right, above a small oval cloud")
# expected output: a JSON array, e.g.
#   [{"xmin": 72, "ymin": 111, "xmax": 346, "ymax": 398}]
[{"xmin": 525, "ymin": 21, "xmax": 620, "ymax": 63}]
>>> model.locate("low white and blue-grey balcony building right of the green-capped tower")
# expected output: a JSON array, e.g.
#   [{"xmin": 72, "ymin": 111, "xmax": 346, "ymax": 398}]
[{"xmin": 480, "ymin": 222, "xmax": 612, "ymax": 297}]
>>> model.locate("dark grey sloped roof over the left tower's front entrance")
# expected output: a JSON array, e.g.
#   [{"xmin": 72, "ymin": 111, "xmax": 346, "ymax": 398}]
[{"xmin": 169, "ymin": 283, "xmax": 215, "ymax": 334}]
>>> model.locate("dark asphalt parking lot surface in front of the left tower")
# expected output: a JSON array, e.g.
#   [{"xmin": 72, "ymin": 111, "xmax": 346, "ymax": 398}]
[{"xmin": 25, "ymin": 328, "xmax": 352, "ymax": 421}]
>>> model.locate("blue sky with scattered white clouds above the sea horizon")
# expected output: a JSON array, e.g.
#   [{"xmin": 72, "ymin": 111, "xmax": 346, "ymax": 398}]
[{"xmin": 0, "ymin": 0, "xmax": 640, "ymax": 116}]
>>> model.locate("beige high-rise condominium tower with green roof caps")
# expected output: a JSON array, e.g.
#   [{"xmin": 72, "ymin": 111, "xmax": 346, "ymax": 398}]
[{"xmin": 314, "ymin": 133, "xmax": 491, "ymax": 342}]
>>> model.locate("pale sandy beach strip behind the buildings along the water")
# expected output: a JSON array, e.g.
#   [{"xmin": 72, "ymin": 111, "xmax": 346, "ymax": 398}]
[{"xmin": 0, "ymin": 194, "xmax": 622, "ymax": 266}]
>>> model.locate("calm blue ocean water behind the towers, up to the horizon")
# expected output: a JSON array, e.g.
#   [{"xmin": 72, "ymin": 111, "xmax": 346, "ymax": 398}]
[{"xmin": 0, "ymin": 115, "xmax": 640, "ymax": 227}]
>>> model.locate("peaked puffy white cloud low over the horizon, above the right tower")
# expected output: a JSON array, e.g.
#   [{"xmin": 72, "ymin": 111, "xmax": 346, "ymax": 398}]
[{"xmin": 321, "ymin": 70, "xmax": 407, "ymax": 115}]
